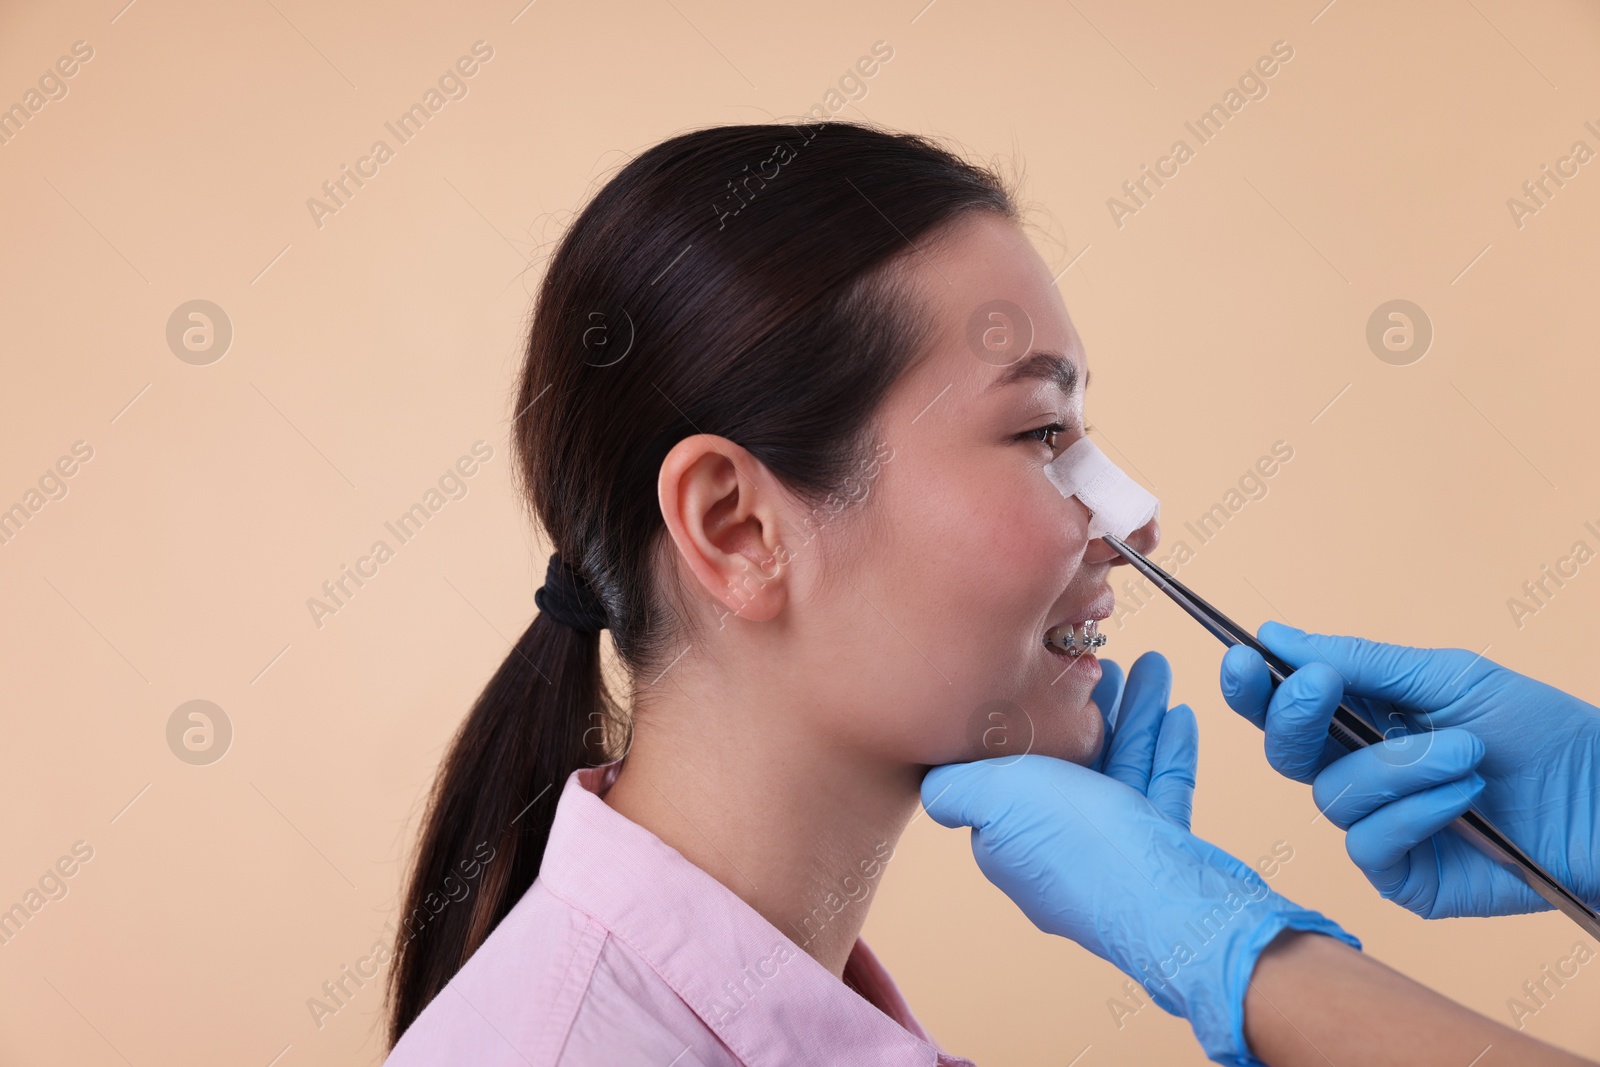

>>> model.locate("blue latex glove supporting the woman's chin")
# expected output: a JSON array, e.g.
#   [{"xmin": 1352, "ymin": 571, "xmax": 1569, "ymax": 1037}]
[{"xmin": 922, "ymin": 653, "xmax": 1360, "ymax": 1065}]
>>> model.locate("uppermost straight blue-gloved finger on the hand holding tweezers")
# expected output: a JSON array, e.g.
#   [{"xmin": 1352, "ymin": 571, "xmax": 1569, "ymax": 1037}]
[{"xmin": 1258, "ymin": 621, "xmax": 1498, "ymax": 712}]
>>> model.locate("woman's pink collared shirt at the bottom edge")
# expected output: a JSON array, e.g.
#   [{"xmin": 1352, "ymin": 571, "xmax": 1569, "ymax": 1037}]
[{"xmin": 386, "ymin": 763, "xmax": 973, "ymax": 1067}]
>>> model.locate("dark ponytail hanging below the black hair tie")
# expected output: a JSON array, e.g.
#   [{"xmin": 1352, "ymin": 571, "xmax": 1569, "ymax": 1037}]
[{"xmin": 389, "ymin": 611, "xmax": 611, "ymax": 1048}]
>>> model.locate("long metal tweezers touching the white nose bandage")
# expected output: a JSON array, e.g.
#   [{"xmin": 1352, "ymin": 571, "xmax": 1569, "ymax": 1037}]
[{"xmin": 1104, "ymin": 534, "xmax": 1600, "ymax": 937}]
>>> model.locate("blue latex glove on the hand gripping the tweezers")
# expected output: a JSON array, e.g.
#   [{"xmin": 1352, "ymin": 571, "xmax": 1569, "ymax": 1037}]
[{"xmin": 1222, "ymin": 622, "xmax": 1600, "ymax": 918}]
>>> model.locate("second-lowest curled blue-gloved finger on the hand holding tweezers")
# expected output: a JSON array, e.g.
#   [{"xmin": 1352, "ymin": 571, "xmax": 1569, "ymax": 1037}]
[{"xmin": 1310, "ymin": 729, "xmax": 1485, "ymax": 837}]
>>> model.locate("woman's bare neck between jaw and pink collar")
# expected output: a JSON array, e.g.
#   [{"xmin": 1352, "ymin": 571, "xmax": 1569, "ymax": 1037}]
[{"xmin": 605, "ymin": 687, "xmax": 925, "ymax": 977}]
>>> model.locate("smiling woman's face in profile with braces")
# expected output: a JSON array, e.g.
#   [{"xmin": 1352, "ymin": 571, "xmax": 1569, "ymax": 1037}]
[{"xmin": 786, "ymin": 213, "xmax": 1160, "ymax": 765}]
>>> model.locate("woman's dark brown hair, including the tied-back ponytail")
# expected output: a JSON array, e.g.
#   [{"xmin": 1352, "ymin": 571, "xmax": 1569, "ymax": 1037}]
[{"xmin": 387, "ymin": 123, "xmax": 1019, "ymax": 1046}]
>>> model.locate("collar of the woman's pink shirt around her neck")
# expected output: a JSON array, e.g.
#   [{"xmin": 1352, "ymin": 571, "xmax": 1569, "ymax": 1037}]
[{"xmin": 539, "ymin": 761, "xmax": 966, "ymax": 1067}]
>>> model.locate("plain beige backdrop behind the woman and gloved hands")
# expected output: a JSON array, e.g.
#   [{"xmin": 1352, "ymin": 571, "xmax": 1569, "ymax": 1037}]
[{"xmin": 0, "ymin": 0, "xmax": 1600, "ymax": 1067}]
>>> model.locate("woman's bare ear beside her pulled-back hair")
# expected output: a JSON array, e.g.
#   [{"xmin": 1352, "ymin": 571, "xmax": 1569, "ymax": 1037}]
[{"xmin": 656, "ymin": 434, "xmax": 789, "ymax": 622}]
